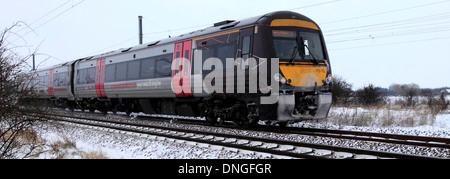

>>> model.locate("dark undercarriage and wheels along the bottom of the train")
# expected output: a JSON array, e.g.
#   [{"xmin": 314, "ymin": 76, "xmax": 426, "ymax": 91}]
[{"xmin": 45, "ymin": 89, "xmax": 331, "ymax": 126}]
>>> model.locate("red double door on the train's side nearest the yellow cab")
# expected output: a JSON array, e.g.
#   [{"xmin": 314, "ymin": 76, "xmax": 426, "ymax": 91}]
[{"xmin": 172, "ymin": 40, "xmax": 192, "ymax": 97}]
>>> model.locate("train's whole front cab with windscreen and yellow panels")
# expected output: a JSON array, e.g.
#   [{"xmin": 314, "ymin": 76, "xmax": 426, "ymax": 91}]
[{"xmin": 260, "ymin": 13, "xmax": 332, "ymax": 124}]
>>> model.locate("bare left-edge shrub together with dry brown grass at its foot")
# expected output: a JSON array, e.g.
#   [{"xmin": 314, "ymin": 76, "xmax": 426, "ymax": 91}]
[{"xmin": 0, "ymin": 23, "xmax": 106, "ymax": 159}]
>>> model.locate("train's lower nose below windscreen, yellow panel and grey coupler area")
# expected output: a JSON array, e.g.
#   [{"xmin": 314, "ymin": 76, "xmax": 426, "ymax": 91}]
[{"xmin": 278, "ymin": 62, "xmax": 332, "ymax": 121}]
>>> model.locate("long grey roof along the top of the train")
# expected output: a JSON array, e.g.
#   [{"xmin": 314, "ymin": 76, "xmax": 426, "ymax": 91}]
[{"xmin": 40, "ymin": 11, "xmax": 315, "ymax": 68}]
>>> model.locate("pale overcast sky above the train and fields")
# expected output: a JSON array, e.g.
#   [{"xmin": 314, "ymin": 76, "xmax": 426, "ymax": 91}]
[{"xmin": 0, "ymin": 0, "xmax": 450, "ymax": 89}]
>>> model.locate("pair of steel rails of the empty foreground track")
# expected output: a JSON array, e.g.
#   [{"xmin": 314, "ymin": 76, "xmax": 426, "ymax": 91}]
[{"xmin": 44, "ymin": 115, "xmax": 437, "ymax": 159}]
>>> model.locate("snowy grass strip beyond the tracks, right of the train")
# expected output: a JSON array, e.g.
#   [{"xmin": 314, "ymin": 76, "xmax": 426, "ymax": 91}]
[{"xmin": 293, "ymin": 107, "xmax": 450, "ymax": 138}]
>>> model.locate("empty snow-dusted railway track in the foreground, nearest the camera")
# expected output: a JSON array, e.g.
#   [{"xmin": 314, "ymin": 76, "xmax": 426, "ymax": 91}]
[{"xmin": 43, "ymin": 114, "xmax": 442, "ymax": 159}]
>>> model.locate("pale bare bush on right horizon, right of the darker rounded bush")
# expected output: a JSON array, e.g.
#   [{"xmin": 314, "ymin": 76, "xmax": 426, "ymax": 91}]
[{"xmin": 390, "ymin": 83, "xmax": 421, "ymax": 107}]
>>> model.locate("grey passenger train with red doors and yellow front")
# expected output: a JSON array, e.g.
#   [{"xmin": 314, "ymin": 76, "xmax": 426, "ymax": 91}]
[{"xmin": 30, "ymin": 11, "xmax": 332, "ymax": 126}]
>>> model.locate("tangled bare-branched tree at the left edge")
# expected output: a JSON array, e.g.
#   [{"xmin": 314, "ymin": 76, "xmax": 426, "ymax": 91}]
[{"xmin": 0, "ymin": 24, "xmax": 45, "ymax": 159}]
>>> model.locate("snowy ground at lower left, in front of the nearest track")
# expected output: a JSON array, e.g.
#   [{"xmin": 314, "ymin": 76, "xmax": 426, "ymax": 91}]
[{"xmin": 37, "ymin": 121, "xmax": 257, "ymax": 159}]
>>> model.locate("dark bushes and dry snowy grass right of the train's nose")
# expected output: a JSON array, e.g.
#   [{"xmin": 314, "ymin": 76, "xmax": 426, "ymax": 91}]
[{"xmin": 326, "ymin": 77, "xmax": 450, "ymax": 127}]
